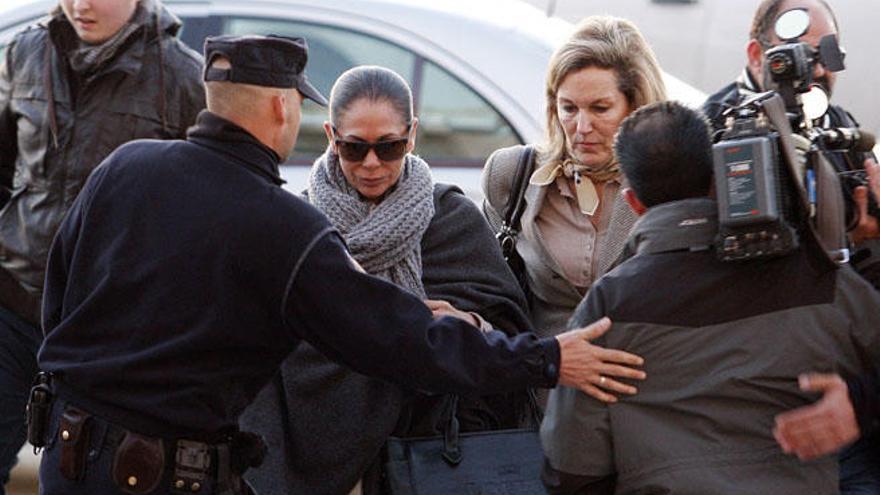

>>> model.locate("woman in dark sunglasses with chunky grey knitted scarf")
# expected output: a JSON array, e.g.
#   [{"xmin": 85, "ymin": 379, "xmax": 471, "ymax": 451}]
[{"xmin": 242, "ymin": 66, "xmax": 531, "ymax": 494}]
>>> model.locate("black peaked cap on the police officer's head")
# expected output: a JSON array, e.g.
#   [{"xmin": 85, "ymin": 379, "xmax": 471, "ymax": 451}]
[{"xmin": 205, "ymin": 35, "xmax": 327, "ymax": 105}]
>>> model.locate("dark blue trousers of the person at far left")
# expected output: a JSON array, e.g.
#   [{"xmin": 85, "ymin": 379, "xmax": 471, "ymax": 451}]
[{"xmin": 0, "ymin": 306, "xmax": 42, "ymax": 495}]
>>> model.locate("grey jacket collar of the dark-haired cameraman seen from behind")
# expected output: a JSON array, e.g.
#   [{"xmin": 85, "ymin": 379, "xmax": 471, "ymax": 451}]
[{"xmin": 627, "ymin": 198, "xmax": 718, "ymax": 254}]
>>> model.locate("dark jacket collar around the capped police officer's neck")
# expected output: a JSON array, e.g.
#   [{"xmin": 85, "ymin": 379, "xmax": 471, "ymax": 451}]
[{"xmin": 186, "ymin": 110, "xmax": 285, "ymax": 186}]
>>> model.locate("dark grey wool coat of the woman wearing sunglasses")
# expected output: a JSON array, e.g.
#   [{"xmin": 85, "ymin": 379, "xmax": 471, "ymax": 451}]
[{"xmin": 241, "ymin": 184, "xmax": 529, "ymax": 495}]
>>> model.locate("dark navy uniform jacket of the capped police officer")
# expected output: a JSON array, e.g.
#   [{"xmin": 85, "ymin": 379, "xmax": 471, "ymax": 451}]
[{"xmin": 39, "ymin": 112, "xmax": 559, "ymax": 438}]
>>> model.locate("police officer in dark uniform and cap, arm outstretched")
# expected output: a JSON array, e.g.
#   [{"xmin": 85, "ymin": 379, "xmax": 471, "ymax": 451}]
[{"xmin": 32, "ymin": 36, "xmax": 624, "ymax": 495}]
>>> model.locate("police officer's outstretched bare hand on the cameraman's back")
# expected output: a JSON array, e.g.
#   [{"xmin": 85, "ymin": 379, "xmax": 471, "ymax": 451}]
[{"xmin": 556, "ymin": 317, "xmax": 647, "ymax": 402}]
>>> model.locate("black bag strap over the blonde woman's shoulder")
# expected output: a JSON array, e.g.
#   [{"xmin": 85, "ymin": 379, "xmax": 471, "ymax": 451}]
[{"xmin": 495, "ymin": 145, "xmax": 535, "ymax": 295}]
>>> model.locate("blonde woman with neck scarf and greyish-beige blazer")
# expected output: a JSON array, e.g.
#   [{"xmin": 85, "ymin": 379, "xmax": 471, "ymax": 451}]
[{"xmin": 483, "ymin": 16, "xmax": 666, "ymax": 402}]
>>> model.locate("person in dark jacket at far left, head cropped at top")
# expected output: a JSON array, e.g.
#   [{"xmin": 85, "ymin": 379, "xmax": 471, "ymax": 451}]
[{"xmin": 0, "ymin": 0, "xmax": 205, "ymax": 488}]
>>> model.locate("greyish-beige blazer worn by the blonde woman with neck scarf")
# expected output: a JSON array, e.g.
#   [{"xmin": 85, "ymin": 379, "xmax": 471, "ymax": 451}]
[{"xmin": 482, "ymin": 145, "xmax": 636, "ymax": 336}]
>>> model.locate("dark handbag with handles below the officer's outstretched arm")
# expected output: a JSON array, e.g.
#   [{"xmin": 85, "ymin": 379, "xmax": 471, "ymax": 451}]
[{"xmin": 385, "ymin": 390, "xmax": 546, "ymax": 495}]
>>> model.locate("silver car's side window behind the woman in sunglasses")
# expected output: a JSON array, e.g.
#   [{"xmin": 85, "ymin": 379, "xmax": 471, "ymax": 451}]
[{"xmin": 222, "ymin": 17, "xmax": 519, "ymax": 167}]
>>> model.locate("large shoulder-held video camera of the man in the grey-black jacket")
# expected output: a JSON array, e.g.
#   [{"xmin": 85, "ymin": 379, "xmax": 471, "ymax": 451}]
[{"xmin": 713, "ymin": 9, "xmax": 880, "ymax": 263}]
